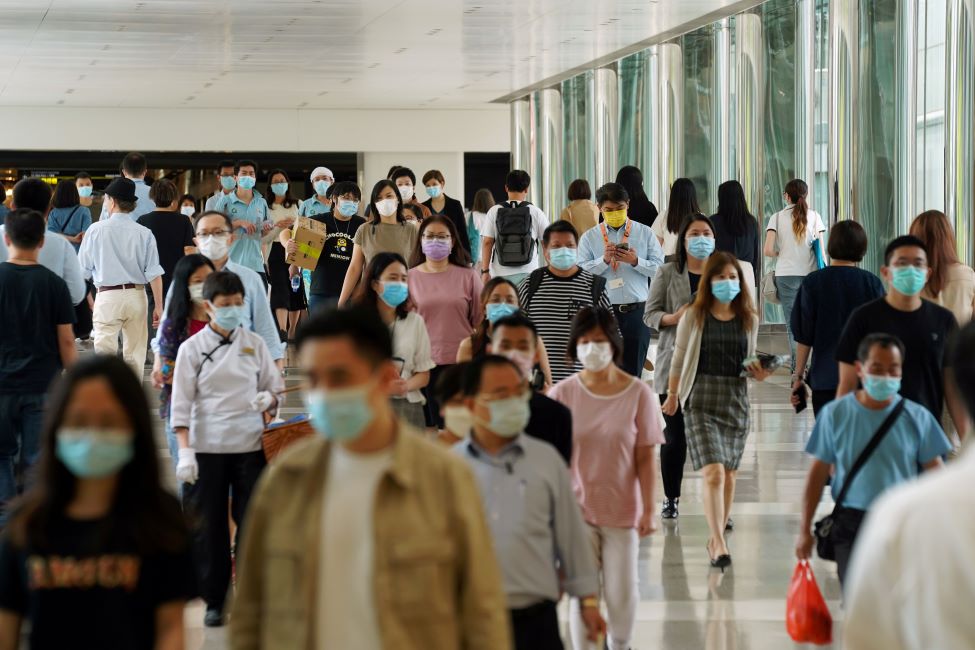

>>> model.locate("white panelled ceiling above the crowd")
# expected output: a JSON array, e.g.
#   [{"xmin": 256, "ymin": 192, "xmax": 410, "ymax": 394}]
[{"xmin": 0, "ymin": 0, "xmax": 740, "ymax": 109}]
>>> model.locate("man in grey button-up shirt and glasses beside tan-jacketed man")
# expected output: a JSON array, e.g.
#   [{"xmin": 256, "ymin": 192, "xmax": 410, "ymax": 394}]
[{"xmin": 454, "ymin": 355, "xmax": 606, "ymax": 650}]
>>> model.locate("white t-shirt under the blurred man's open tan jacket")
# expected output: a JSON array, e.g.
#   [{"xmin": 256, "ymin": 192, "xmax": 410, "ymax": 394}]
[{"xmin": 318, "ymin": 444, "xmax": 393, "ymax": 650}]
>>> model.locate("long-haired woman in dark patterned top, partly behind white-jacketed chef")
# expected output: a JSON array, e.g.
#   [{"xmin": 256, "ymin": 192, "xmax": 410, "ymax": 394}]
[{"xmin": 152, "ymin": 254, "xmax": 214, "ymax": 470}]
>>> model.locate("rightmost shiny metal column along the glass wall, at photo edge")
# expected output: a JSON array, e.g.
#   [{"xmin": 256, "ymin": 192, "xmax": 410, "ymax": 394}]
[{"xmin": 945, "ymin": 0, "xmax": 975, "ymax": 265}]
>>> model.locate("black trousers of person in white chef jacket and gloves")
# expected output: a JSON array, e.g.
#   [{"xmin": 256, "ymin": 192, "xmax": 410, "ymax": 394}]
[{"xmin": 183, "ymin": 451, "xmax": 267, "ymax": 611}]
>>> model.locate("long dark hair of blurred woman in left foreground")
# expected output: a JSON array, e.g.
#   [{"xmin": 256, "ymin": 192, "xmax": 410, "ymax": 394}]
[{"xmin": 9, "ymin": 355, "xmax": 188, "ymax": 555}]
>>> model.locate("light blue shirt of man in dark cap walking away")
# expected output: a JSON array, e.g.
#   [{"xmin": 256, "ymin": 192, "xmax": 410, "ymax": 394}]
[{"xmin": 78, "ymin": 212, "xmax": 163, "ymax": 287}]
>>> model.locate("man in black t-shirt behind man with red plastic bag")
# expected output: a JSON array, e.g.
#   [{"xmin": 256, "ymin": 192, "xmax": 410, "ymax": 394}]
[{"xmin": 836, "ymin": 235, "xmax": 967, "ymax": 439}]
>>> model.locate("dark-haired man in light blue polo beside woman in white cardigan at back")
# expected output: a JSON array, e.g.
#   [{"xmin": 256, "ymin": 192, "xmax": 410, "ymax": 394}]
[{"xmin": 217, "ymin": 160, "xmax": 273, "ymax": 286}]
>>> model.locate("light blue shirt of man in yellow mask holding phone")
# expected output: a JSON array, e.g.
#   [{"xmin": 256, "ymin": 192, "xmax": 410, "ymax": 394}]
[{"xmin": 579, "ymin": 219, "xmax": 664, "ymax": 305}]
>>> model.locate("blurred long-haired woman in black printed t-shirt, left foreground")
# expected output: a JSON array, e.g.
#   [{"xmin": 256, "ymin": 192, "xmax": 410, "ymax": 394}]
[{"xmin": 0, "ymin": 356, "xmax": 196, "ymax": 650}]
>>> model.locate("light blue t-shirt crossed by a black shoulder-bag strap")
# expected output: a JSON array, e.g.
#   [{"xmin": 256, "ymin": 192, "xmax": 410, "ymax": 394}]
[{"xmin": 806, "ymin": 393, "xmax": 951, "ymax": 510}]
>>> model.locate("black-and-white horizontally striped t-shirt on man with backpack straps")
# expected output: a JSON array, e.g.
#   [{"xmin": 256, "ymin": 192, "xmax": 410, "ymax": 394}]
[{"xmin": 518, "ymin": 269, "xmax": 613, "ymax": 382}]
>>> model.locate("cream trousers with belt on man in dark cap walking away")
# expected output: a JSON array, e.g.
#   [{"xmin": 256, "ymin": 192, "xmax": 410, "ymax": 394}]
[{"xmin": 91, "ymin": 289, "xmax": 149, "ymax": 381}]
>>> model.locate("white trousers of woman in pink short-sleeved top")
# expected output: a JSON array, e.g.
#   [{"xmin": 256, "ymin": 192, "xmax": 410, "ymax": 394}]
[{"xmin": 569, "ymin": 525, "xmax": 640, "ymax": 650}]
